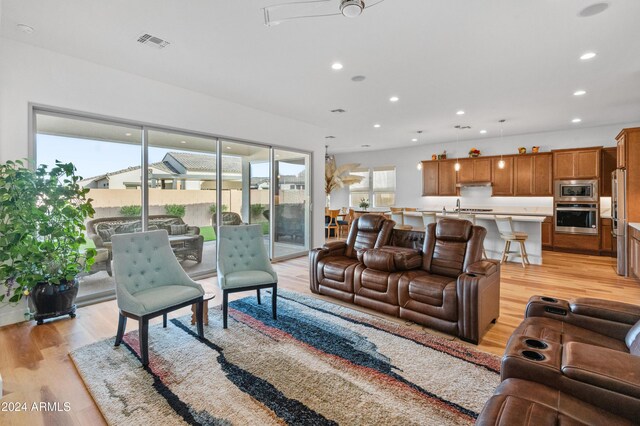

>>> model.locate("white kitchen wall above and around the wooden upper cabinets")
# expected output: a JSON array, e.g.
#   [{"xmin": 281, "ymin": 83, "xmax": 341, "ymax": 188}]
[{"xmin": 331, "ymin": 121, "xmax": 640, "ymax": 209}]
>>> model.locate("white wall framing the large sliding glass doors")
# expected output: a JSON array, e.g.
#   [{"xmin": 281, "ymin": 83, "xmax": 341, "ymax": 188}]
[{"xmin": 0, "ymin": 38, "xmax": 325, "ymax": 325}]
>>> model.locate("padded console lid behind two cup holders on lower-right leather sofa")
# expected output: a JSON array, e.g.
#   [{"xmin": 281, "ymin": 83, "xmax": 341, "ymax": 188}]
[{"xmin": 561, "ymin": 342, "xmax": 640, "ymax": 398}]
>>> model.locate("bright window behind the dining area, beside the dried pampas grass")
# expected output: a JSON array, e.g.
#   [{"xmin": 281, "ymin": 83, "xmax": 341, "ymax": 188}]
[{"xmin": 349, "ymin": 166, "xmax": 396, "ymax": 207}]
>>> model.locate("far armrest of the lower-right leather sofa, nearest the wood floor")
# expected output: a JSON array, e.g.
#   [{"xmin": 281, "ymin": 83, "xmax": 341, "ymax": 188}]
[{"xmin": 525, "ymin": 296, "xmax": 640, "ymax": 340}]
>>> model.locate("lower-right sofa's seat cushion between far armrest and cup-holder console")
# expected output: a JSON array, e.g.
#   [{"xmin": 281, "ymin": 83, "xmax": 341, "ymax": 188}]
[{"xmin": 513, "ymin": 317, "xmax": 628, "ymax": 352}]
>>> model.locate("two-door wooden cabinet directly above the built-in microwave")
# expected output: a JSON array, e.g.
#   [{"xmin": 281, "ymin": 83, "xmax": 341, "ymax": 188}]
[{"xmin": 553, "ymin": 147, "xmax": 602, "ymax": 179}]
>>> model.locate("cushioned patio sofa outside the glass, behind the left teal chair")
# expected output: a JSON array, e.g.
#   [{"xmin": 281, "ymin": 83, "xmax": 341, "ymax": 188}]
[{"xmin": 87, "ymin": 215, "xmax": 204, "ymax": 268}]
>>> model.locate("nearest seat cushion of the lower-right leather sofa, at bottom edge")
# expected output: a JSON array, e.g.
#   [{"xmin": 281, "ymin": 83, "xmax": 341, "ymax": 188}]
[{"xmin": 476, "ymin": 379, "xmax": 632, "ymax": 426}]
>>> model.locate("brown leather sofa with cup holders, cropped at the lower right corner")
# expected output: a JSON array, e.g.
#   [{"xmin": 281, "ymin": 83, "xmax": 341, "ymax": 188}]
[{"xmin": 478, "ymin": 296, "xmax": 640, "ymax": 425}]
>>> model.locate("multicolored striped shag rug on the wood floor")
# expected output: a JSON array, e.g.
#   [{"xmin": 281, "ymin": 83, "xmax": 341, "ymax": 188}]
[{"xmin": 71, "ymin": 290, "xmax": 500, "ymax": 425}]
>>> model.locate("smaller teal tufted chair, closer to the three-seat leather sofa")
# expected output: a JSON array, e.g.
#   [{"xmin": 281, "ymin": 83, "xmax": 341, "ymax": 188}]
[{"xmin": 218, "ymin": 225, "xmax": 278, "ymax": 328}]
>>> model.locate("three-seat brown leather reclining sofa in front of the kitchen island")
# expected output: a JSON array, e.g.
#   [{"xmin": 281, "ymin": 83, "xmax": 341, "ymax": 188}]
[{"xmin": 310, "ymin": 215, "xmax": 500, "ymax": 343}]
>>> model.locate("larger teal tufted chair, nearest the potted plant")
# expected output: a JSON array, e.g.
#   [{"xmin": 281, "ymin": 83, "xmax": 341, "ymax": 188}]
[{"xmin": 111, "ymin": 229, "xmax": 204, "ymax": 366}]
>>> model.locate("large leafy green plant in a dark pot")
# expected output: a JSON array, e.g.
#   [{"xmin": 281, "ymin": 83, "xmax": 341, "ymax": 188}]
[{"xmin": 0, "ymin": 161, "xmax": 96, "ymax": 324}]
